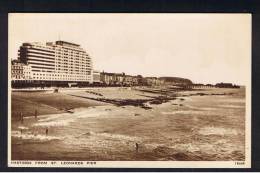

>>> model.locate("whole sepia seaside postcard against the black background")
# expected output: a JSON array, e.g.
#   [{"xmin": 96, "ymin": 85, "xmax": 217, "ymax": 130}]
[{"xmin": 8, "ymin": 13, "xmax": 251, "ymax": 168}]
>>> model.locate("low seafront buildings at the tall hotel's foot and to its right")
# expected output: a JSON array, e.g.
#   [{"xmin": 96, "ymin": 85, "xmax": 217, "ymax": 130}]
[{"xmin": 11, "ymin": 60, "xmax": 191, "ymax": 87}]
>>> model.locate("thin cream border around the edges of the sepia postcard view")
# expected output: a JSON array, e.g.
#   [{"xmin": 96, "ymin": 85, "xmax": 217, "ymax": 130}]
[{"xmin": 7, "ymin": 13, "xmax": 252, "ymax": 168}]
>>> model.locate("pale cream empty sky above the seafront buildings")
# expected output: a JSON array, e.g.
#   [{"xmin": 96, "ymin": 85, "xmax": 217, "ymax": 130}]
[{"xmin": 8, "ymin": 13, "xmax": 251, "ymax": 85}]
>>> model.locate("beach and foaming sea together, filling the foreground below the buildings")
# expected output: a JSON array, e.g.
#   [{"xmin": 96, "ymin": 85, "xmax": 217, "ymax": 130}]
[{"xmin": 11, "ymin": 87, "xmax": 245, "ymax": 161}]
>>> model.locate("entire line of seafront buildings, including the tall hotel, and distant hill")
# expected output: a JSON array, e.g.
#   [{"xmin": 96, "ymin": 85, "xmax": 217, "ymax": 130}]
[{"xmin": 11, "ymin": 40, "xmax": 240, "ymax": 88}]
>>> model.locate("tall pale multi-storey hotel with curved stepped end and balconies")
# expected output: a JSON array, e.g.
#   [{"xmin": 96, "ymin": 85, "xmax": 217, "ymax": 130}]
[{"xmin": 18, "ymin": 41, "xmax": 93, "ymax": 83}]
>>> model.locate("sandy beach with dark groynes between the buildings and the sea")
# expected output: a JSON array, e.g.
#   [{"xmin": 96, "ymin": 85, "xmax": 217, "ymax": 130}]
[{"xmin": 11, "ymin": 87, "xmax": 243, "ymax": 120}]
